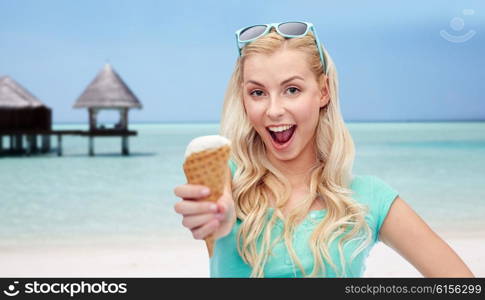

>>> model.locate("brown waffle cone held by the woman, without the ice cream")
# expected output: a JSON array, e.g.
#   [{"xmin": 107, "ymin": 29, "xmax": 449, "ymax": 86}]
[{"xmin": 183, "ymin": 145, "xmax": 231, "ymax": 257}]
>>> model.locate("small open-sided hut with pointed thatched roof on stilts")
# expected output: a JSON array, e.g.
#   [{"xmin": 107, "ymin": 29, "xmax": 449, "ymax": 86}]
[{"xmin": 73, "ymin": 64, "xmax": 142, "ymax": 155}]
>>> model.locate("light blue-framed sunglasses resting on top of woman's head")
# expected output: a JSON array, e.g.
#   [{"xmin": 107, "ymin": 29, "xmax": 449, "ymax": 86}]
[{"xmin": 236, "ymin": 22, "xmax": 327, "ymax": 73}]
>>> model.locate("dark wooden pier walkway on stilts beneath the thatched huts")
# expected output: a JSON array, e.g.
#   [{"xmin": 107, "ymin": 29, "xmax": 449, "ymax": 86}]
[{"xmin": 0, "ymin": 129, "xmax": 138, "ymax": 156}]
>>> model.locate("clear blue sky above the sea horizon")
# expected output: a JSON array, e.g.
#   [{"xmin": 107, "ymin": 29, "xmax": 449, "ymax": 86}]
[{"xmin": 0, "ymin": 0, "xmax": 485, "ymax": 123}]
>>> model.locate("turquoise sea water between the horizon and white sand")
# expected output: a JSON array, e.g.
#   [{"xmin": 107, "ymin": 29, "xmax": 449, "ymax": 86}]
[{"xmin": 0, "ymin": 122, "xmax": 485, "ymax": 246}]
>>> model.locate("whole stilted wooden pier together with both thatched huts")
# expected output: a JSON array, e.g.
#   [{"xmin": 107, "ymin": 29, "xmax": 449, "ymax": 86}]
[{"xmin": 0, "ymin": 64, "xmax": 142, "ymax": 156}]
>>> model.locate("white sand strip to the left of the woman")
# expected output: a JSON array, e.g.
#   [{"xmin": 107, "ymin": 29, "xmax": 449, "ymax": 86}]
[{"xmin": 0, "ymin": 237, "xmax": 209, "ymax": 277}]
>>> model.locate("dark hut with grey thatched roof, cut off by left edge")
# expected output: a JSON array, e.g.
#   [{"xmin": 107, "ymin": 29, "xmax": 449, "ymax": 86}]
[{"xmin": 0, "ymin": 76, "xmax": 52, "ymax": 153}]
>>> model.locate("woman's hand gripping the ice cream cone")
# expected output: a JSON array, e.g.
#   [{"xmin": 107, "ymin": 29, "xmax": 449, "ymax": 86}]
[{"xmin": 174, "ymin": 173, "xmax": 236, "ymax": 240}]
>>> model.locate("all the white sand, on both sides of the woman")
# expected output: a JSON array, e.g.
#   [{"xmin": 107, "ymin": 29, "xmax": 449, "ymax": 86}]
[{"xmin": 0, "ymin": 235, "xmax": 485, "ymax": 277}]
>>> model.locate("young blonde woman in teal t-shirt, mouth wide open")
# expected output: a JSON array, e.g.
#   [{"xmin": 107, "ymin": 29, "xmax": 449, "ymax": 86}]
[{"xmin": 174, "ymin": 22, "xmax": 473, "ymax": 277}]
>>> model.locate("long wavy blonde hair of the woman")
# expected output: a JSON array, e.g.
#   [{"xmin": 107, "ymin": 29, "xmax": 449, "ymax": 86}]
[{"xmin": 220, "ymin": 30, "xmax": 372, "ymax": 277}]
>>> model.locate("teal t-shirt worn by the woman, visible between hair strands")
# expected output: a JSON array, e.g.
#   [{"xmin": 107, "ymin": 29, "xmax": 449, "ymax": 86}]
[{"xmin": 210, "ymin": 161, "xmax": 398, "ymax": 277}]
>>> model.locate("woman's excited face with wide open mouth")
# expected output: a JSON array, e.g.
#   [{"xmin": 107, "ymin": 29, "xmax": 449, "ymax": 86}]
[{"xmin": 242, "ymin": 49, "xmax": 329, "ymax": 161}]
